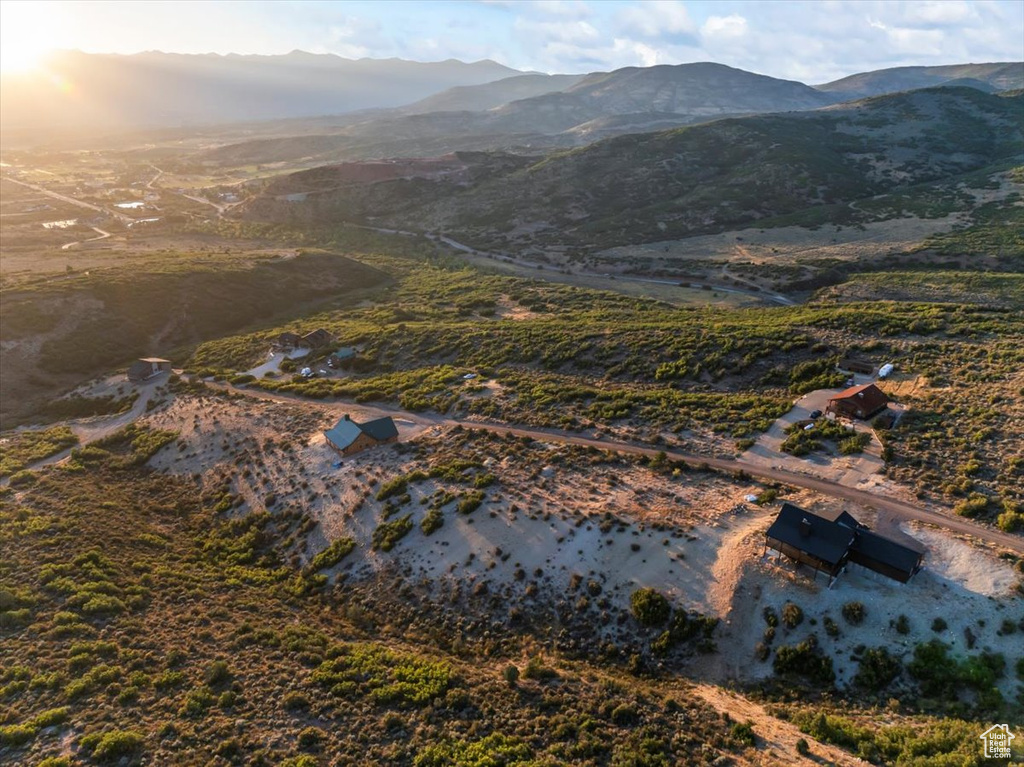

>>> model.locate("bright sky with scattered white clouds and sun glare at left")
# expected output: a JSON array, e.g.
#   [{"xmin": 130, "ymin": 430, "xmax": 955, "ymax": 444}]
[{"xmin": 0, "ymin": 0, "xmax": 1024, "ymax": 84}]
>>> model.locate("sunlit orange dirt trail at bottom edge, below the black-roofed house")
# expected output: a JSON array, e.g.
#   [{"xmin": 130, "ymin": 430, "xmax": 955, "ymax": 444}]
[{"xmin": 693, "ymin": 684, "xmax": 868, "ymax": 766}]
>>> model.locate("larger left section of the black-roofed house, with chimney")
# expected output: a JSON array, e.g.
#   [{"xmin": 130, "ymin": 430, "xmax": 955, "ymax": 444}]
[{"xmin": 765, "ymin": 503, "xmax": 855, "ymax": 584}]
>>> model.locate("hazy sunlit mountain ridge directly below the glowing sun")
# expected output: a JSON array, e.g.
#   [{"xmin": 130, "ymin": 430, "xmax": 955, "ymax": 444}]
[{"xmin": 0, "ymin": 51, "xmax": 522, "ymax": 130}]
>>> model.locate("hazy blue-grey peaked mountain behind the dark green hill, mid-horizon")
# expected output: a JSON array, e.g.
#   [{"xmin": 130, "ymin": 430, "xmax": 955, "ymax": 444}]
[{"xmin": 202, "ymin": 62, "xmax": 836, "ymax": 164}]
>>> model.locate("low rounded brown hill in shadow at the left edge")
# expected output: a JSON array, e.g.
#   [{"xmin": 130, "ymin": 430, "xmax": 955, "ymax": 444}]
[{"xmin": 0, "ymin": 253, "xmax": 388, "ymax": 425}]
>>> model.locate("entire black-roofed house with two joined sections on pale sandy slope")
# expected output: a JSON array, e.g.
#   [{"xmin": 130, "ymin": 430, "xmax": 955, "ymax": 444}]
[{"xmin": 765, "ymin": 503, "xmax": 924, "ymax": 586}]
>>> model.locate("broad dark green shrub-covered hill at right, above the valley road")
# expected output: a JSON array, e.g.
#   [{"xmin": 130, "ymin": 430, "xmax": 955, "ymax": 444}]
[{"xmin": 243, "ymin": 88, "xmax": 1024, "ymax": 247}]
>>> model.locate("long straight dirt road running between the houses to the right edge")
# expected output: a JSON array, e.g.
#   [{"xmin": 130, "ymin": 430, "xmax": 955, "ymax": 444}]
[{"xmin": 208, "ymin": 384, "xmax": 1024, "ymax": 555}]
